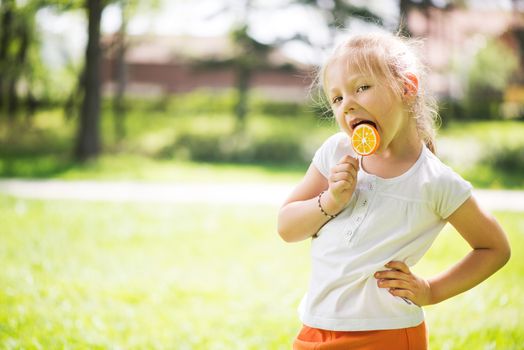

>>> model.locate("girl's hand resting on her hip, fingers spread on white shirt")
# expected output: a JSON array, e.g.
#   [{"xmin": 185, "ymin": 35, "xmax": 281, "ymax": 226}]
[{"xmin": 375, "ymin": 261, "xmax": 431, "ymax": 306}]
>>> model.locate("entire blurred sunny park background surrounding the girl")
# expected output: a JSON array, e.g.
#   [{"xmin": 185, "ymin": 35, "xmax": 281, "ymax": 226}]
[{"xmin": 0, "ymin": 0, "xmax": 524, "ymax": 349}]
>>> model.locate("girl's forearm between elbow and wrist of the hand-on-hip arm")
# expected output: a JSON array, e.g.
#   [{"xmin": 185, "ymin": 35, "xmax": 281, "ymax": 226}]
[{"xmin": 428, "ymin": 248, "xmax": 509, "ymax": 304}]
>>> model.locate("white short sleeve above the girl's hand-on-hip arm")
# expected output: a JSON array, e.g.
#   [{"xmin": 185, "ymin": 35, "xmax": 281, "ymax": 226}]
[{"xmin": 436, "ymin": 167, "xmax": 473, "ymax": 219}]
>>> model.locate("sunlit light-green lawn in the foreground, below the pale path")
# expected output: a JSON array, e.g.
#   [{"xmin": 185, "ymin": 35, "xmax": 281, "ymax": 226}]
[{"xmin": 0, "ymin": 196, "xmax": 524, "ymax": 350}]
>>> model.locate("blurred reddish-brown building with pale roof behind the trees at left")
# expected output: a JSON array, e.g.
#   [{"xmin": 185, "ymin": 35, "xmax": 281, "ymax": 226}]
[{"xmin": 102, "ymin": 37, "xmax": 312, "ymax": 101}]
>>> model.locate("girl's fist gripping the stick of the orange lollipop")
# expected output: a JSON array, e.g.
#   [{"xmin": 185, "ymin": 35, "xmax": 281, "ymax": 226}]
[{"xmin": 325, "ymin": 155, "xmax": 359, "ymax": 213}]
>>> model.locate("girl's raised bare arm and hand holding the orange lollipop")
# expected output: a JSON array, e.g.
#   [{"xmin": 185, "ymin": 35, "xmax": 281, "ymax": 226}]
[{"xmin": 278, "ymin": 156, "xmax": 358, "ymax": 242}]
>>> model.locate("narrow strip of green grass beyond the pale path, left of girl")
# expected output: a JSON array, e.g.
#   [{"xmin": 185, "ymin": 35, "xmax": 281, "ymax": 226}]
[{"xmin": 0, "ymin": 154, "xmax": 307, "ymax": 183}]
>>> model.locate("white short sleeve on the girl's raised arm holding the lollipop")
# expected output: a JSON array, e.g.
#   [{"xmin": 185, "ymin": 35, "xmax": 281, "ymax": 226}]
[{"xmin": 312, "ymin": 132, "xmax": 354, "ymax": 179}]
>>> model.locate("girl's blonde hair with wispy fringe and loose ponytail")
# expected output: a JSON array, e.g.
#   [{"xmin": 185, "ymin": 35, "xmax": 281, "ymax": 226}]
[{"xmin": 316, "ymin": 32, "xmax": 439, "ymax": 153}]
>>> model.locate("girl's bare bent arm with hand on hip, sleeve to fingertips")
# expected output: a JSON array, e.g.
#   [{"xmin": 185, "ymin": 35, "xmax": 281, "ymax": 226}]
[{"xmin": 375, "ymin": 197, "xmax": 511, "ymax": 306}]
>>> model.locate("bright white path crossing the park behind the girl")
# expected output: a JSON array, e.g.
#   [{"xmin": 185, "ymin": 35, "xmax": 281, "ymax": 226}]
[{"xmin": 0, "ymin": 179, "xmax": 524, "ymax": 211}]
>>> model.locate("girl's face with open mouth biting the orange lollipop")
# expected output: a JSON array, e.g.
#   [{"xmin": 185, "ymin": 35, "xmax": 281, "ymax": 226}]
[{"xmin": 325, "ymin": 59, "xmax": 409, "ymax": 152}]
